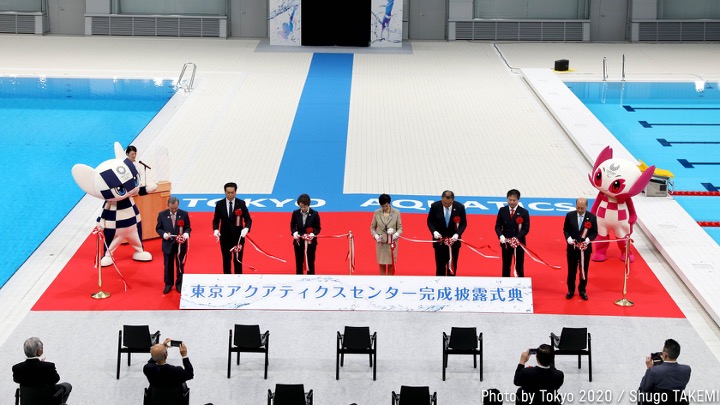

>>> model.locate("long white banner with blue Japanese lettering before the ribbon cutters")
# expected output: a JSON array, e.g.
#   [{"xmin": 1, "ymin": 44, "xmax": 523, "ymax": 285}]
[{"xmin": 180, "ymin": 274, "xmax": 533, "ymax": 313}]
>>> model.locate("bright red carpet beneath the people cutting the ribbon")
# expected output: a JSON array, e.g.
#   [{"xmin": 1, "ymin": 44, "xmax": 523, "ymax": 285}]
[{"xmin": 33, "ymin": 212, "xmax": 684, "ymax": 318}]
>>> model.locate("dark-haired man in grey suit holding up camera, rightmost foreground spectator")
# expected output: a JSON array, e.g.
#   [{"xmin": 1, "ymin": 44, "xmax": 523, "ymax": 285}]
[{"xmin": 638, "ymin": 339, "xmax": 691, "ymax": 402}]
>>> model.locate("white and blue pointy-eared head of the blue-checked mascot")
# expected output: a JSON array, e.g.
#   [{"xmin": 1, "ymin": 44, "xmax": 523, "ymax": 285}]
[{"xmin": 72, "ymin": 142, "xmax": 139, "ymax": 201}]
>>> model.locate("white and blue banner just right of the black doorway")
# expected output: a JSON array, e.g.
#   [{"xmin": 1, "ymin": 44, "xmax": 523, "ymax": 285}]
[{"xmin": 370, "ymin": 0, "xmax": 403, "ymax": 47}]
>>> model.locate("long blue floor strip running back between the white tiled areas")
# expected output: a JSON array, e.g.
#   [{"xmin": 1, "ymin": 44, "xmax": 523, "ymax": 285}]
[{"xmin": 273, "ymin": 53, "xmax": 353, "ymax": 196}]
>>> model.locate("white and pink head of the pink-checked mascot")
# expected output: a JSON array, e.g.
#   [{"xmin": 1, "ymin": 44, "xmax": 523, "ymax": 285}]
[{"xmin": 588, "ymin": 146, "xmax": 655, "ymax": 199}]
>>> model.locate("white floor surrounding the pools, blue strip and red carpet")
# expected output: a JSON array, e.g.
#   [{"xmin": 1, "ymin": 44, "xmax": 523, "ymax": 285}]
[{"xmin": 0, "ymin": 35, "xmax": 720, "ymax": 405}]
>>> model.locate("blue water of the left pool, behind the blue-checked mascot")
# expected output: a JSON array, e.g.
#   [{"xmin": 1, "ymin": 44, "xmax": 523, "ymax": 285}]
[{"xmin": 0, "ymin": 77, "xmax": 175, "ymax": 286}]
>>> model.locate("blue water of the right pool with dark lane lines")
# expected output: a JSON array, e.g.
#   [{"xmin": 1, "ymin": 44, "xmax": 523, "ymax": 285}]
[{"xmin": 565, "ymin": 82, "xmax": 720, "ymax": 244}]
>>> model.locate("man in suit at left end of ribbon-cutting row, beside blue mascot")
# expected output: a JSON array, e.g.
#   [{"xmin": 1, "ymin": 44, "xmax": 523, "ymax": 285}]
[{"xmin": 155, "ymin": 196, "xmax": 190, "ymax": 294}]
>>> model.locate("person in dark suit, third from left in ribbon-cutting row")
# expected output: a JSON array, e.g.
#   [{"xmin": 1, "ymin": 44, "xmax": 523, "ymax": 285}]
[{"xmin": 290, "ymin": 194, "xmax": 320, "ymax": 274}]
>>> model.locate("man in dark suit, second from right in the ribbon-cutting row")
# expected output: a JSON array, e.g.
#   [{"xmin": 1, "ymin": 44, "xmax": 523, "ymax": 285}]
[{"xmin": 495, "ymin": 189, "xmax": 530, "ymax": 277}]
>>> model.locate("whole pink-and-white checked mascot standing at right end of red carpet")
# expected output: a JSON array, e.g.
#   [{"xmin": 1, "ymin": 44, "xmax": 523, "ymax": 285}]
[{"xmin": 588, "ymin": 146, "xmax": 655, "ymax": 262}]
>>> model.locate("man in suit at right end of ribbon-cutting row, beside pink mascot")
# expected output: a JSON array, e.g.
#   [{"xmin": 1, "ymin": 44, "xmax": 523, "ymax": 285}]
[{"xmin": 563, "ymin": 198, "xmax": 597, "ymax": 300}]
